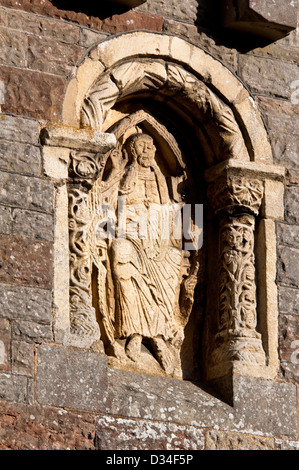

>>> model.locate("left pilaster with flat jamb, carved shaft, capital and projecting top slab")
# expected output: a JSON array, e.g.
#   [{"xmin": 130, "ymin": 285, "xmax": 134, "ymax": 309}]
[{"xmin": 41, "ymin": 125, "xmax": 116, "ymax": 348}]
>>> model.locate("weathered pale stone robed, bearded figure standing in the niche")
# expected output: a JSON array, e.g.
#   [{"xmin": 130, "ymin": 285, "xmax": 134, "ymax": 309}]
[{"xmin": 91, "ymin": 129, "xmax": 202, "ymax": 375}]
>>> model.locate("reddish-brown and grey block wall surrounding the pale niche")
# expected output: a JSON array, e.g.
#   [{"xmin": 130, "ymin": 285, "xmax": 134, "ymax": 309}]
[{"xmin": 0, "ymin": 0, "xmax": 299, "ymax": 450}]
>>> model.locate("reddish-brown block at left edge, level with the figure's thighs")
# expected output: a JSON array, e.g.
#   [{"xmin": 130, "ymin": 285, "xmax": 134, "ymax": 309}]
[{"xmin": 0, "ymin": 235, "xmax": 53, "ymax": 288}]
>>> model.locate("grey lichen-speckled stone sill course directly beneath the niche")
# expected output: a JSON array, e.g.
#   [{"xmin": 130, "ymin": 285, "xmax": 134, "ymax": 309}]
[{"xmin": 36, "ymin": 344, "xmax": 297, "ymax": 440}]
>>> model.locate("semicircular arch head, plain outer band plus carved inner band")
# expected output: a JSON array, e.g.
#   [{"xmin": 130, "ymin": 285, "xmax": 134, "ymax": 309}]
[{"xmin": 62, "ymin": 32, "xmax": 272, "ymax": 162}]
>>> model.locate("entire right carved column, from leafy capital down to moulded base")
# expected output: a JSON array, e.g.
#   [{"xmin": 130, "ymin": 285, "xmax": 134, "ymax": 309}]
[{"xmin": 208, "ymin": 172, "xmax": 265, "ymax": 376}]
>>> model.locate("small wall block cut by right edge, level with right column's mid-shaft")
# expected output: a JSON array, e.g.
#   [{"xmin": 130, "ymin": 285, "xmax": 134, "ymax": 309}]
[{"xmin": 277, "ymin": 246, "xmax": 299, "ymax": 287}]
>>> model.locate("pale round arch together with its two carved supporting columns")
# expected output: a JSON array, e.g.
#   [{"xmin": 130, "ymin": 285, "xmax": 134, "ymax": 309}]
[{"xmin": 43, "ymin": 32, "xmax": 284, "ymax": 390}]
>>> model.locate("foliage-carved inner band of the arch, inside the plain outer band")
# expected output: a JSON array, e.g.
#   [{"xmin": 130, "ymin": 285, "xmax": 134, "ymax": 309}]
[{"xmin": 81, "ymin": 58, "xmax": 249, "ymax": 161}]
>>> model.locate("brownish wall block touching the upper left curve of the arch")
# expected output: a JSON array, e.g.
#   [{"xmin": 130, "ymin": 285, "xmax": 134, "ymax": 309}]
[{"xmin": 28, "ymin": 36, "xmax": 85, "ymax": 77}]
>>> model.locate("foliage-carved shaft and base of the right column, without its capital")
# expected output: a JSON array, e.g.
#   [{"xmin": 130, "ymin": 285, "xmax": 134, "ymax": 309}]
[{"xmin": 212, "ymin": 215, "xmax": 265, "ymax": 365}]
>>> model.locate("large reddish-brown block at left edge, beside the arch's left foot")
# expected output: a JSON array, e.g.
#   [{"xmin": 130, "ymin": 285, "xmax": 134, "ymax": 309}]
[{"xmin": 0, "ymin": 66, "xmax": 65, "ymax": 122}]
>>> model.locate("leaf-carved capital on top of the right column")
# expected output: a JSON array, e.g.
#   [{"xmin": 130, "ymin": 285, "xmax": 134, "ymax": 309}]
[{"xmin": 208, "ymin": 175, "xmax": 264, "ymax": 215}]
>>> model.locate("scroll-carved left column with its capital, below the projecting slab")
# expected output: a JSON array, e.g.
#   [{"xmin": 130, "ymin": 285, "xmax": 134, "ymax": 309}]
[{"xmin": 68, "ymin": 150, "xmax": 105, "ymax": 341}]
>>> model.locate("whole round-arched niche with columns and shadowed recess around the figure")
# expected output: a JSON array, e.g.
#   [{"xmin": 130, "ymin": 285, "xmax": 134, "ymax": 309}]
[{"xmin": 45, "ymin": 32, "xmax": 283, "ymax": 388}]
